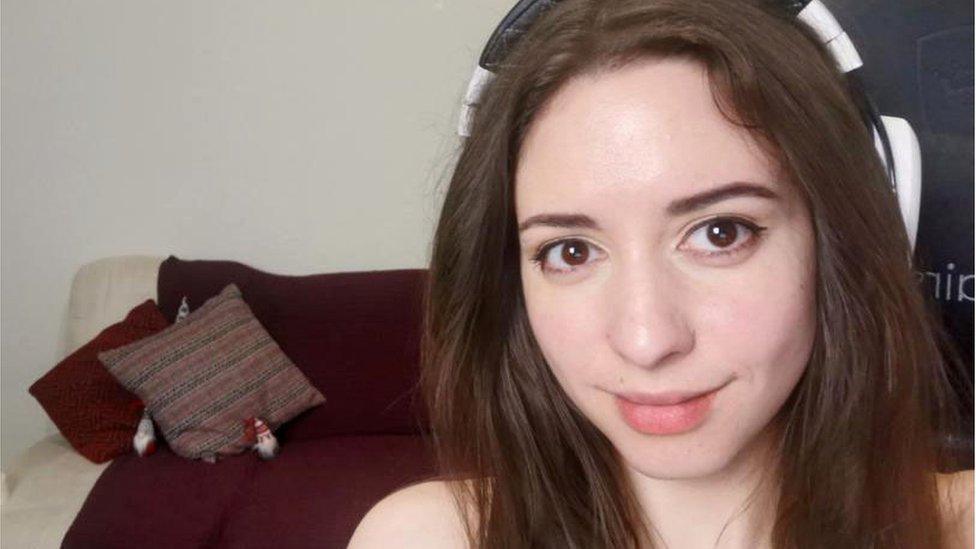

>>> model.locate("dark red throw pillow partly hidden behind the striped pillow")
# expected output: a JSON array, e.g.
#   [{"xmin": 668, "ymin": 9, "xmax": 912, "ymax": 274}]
[{"xmin": 29, "ymin": 299, "xmax": 170, "ymax": 463}]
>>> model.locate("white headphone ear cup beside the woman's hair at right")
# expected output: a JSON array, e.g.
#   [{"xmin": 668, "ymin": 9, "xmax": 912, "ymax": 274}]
[{"xmin": 874, "ymin": 115, "xmax": 922, "ymax": 254}]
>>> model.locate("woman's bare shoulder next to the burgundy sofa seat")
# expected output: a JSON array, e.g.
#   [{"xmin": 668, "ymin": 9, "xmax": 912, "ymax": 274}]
[{"xmin": 347, "ymin": 480, "xmax": 468, "ymax": 549}]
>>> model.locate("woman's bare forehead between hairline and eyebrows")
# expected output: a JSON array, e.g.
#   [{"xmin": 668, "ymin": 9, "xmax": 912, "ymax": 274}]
[{"xmin": 515, "ymin": 58, "xmax": 788, "ymax": 213}]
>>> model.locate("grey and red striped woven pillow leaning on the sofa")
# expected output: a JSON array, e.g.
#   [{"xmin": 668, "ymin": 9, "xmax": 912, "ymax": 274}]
[{"xmin": 98, "ymin": 284, "xmax": 325, "ymax": 461}]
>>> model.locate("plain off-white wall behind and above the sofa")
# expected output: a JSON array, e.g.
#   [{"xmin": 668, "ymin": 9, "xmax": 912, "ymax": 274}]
[{"xmin": 0, "ymin": 0, "xmax": 514, "ymax": 466}]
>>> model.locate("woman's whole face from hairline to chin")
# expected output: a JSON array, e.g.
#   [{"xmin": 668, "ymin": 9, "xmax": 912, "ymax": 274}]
[{"xmin": 515, "ymin": 54, "xmax": 816, "ymax": 478}]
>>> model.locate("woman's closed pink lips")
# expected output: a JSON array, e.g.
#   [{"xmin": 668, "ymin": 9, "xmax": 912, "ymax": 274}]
[{"xmin": 616, "ymin": 387, "xmax": 721, "ymax": 435}]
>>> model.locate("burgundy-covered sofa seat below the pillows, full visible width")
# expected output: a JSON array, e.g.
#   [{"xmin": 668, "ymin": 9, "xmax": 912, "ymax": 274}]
[{"xmin": 62, "ymin": 435, "xmax": 434, "ymax": 549}]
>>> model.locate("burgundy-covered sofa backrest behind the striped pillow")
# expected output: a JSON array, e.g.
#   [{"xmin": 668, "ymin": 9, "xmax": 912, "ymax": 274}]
[{"xmin": 158, "ymin": 256, "xmax": 427, "ymax": 443}]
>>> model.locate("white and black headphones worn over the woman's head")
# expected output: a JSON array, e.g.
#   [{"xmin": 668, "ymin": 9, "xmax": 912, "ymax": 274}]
[{"xmin": 457, "ymin": 0, "xmax": 922, "ymax": 250}]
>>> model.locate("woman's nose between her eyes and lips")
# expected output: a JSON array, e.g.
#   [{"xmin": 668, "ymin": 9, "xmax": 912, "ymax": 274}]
[{"xmin": 607, "ymin": 263, "xmax": 695, "ymax": 369}]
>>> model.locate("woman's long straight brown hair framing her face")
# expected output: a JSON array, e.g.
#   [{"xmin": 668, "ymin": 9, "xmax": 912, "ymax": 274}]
[{"xmin": 421, "ymin": 0, "xmax": 961, "ymax": 548}]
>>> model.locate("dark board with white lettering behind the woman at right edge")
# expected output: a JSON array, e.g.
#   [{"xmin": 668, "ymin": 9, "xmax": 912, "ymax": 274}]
[{"xmin": 824, "ymin": 0, "xmax": 976, "ymax": 469}]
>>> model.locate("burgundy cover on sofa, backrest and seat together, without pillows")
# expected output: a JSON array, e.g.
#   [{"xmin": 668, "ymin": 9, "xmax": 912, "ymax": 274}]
[{"xmin": 62, "ymin": 256, "xmax": 434, "ymax": 549}]
